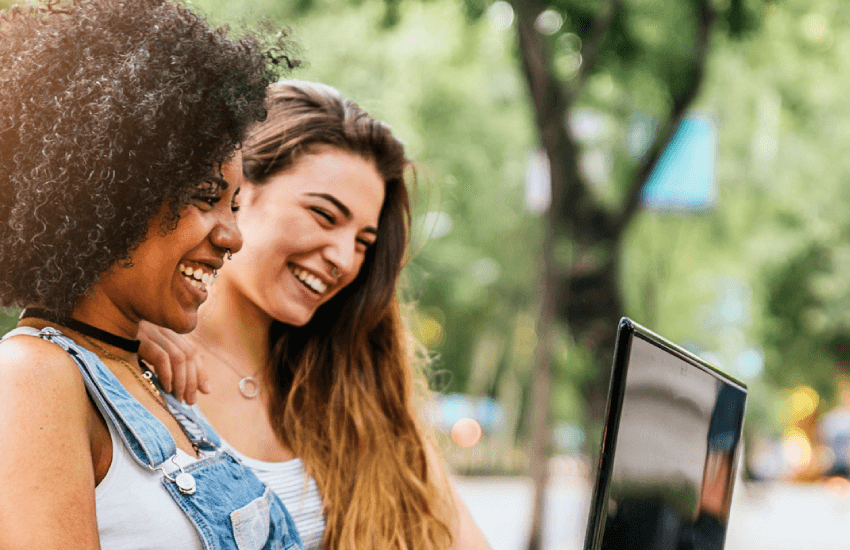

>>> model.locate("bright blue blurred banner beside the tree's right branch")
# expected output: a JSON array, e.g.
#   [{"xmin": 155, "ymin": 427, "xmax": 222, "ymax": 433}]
[{"xmin": 641, "ymin": 116, "xmax": 717, "ymax": 211}]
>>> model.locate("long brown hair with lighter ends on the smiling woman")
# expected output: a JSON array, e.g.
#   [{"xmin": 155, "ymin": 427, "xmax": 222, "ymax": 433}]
[{"xmin": 243, "ymin": 81, "xmax": 452, "ymax": 550}]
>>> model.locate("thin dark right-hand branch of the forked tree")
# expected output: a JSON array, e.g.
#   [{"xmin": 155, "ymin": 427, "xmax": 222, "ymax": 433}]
[{"xmin": 616, "ymin": 0, "xmax": 715, "ymax": 232}]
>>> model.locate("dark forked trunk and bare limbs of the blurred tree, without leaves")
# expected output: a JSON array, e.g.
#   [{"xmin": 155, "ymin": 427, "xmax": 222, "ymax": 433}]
[{"xmin": 511, "ymin": 0, "xmax": 714, "ymax": 550}]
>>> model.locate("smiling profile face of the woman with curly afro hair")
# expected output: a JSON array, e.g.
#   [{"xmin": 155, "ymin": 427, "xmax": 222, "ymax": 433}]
[{"xmin": 80, "ymin": 151, "xmax": 242, "ymax": 336}]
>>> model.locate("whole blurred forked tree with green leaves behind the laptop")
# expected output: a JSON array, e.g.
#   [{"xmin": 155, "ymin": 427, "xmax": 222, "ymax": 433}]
[{"xmin": 494, "ymin": 0, "xmax": 760, "ymax": 550}]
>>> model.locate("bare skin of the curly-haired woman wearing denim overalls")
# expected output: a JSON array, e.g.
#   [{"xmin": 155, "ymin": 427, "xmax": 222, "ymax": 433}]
[{"xmin": 0, "ymin": 154, "xmax": 242, "ymax": 550}]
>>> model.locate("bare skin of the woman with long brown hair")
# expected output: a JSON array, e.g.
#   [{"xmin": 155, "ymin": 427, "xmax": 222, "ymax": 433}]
[{"xmin": 140, "ymin": 148, "xmax": 489, "ymax": 549}]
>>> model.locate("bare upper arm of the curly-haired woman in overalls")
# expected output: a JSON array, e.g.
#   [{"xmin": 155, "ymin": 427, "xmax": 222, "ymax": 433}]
[{"xmin": 0, "ymin": 336, "xmax": 100, "ymax": 550}]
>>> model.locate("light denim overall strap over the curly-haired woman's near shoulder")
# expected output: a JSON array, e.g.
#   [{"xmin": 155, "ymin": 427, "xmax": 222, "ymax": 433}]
[{"xmin": 4, "ymin": 327, "xmax": 177, "ymax": 470}]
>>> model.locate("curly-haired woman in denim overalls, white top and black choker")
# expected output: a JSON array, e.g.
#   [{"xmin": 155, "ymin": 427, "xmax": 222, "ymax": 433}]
[{"xmin": 0, "ymin": 0, "xmax": 300, "ymax": 550}]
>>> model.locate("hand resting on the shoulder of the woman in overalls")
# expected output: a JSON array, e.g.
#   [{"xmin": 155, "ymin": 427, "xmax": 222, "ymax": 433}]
[{"xmin": 139, "ymin": 321, "xmax": 209, "ymax": 405}]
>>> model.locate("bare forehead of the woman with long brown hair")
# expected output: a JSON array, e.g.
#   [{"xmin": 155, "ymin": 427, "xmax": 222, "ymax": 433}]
[{"xmin": 279, "ymin": 149, "xmax": 385, "ymax": 226}]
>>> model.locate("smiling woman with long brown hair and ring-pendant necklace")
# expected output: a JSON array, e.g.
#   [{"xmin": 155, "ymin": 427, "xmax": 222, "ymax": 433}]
[{"xmin": 142, "ymin": 81, "xmax": 488, "ymax": 550}]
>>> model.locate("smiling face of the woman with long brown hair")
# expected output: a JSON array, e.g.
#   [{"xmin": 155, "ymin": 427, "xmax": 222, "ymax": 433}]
[{"xmin": 222, "ymin": 149, "xmax": 384, "ymax": 326}]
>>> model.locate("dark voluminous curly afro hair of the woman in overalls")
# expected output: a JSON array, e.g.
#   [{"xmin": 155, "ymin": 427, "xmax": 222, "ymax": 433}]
[{"xmin": 0, "ymin": 0, "xmax": 291, "ymax": 318}]
